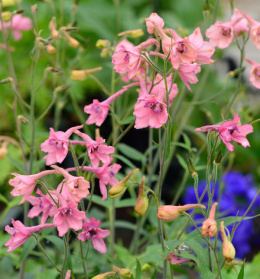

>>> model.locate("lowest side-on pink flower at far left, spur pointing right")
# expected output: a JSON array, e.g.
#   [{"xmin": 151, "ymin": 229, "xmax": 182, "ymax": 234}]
[{"xmin": 5, "ymin": 219, "xmax": 55, "ymax": 253}]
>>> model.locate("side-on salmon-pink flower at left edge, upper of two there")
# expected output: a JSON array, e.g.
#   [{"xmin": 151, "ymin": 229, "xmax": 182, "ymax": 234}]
[{"xmin": 9, "ymin": 170, "xmax": 56, "ymax": 204}]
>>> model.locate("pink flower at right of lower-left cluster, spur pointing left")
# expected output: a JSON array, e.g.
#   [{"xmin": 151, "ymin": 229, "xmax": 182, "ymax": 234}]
[{"xmin": 67, "ymin": 158, "xmax": 121, "ymax": 201}]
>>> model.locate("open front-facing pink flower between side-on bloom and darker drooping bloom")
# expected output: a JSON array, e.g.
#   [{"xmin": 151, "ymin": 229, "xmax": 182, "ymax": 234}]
[{"xmin": 53, "ymin": 201, "xmax": 86, "ymax": 236}]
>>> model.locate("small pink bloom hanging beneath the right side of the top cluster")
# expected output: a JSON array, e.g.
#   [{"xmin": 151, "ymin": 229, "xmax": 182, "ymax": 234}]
[{"xmin": 178, "ymin": 63, "xmax": 201, "ymax": 91}]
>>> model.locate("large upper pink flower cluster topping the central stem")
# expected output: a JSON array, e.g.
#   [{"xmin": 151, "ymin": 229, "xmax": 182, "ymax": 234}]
[{"xmin": 84, "ymin": 13, "xmax": 215, "ymax": 129}]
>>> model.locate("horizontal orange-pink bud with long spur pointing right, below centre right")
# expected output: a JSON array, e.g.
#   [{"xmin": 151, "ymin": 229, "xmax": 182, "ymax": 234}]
[{"xmin": 157, "ymin": 204, "xmax": 206, "ymax": 221}]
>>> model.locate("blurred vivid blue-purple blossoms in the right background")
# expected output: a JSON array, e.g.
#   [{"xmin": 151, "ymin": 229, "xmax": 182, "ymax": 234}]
[{"xmin": 182, "ymin": 171, "xmax": 260, "ymax": 259}]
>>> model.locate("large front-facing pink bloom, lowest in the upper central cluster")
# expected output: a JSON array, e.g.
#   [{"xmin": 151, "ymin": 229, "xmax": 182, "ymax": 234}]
[{"xmin": 133, "ymin": 94, "xmax": 168, "ymax": 129}]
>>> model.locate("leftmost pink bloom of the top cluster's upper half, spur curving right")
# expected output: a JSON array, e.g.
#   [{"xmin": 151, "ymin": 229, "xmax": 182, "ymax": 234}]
[{"xmin": 112, "ymin": 39, "xmax": 159, "ymax": 79}]
